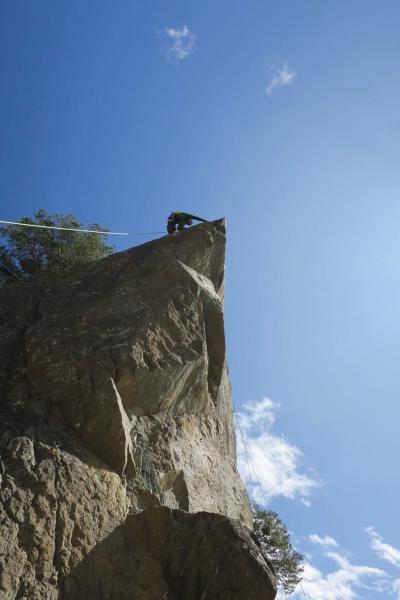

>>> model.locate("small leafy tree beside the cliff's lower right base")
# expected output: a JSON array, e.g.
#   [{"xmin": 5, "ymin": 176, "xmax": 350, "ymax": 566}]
[{"xmin": 251, "ymin": 504, "xmax": 304, "ymax": 594}]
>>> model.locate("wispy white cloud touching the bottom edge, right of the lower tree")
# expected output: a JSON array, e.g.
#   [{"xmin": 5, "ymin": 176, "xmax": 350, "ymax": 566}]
[{"xmin": 286, "ymin": 552, "xmax": 387, "ymax": 600}]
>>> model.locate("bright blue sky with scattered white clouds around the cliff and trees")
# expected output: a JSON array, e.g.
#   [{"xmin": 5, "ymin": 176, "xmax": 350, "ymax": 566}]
[{"xmin": 0, "ymin": 0, "xmax": 400, "ymax": 600}]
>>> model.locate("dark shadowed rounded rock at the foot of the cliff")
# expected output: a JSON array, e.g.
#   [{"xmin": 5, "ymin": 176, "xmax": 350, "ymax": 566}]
[{"xmin": 58, "ymin": 508, "xmax": 276, "ymax": 600}]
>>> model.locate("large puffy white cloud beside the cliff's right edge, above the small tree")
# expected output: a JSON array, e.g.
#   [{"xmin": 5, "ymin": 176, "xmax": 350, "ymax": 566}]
[{"xmin": 237, "ymin": 398, "xmax": 320, "ymax": 506}]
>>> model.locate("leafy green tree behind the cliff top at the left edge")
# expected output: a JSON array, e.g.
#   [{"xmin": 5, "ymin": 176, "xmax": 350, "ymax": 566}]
[{"xmin": 0, "ymin": 209, "xmax": 113, "ymax": 277}]
